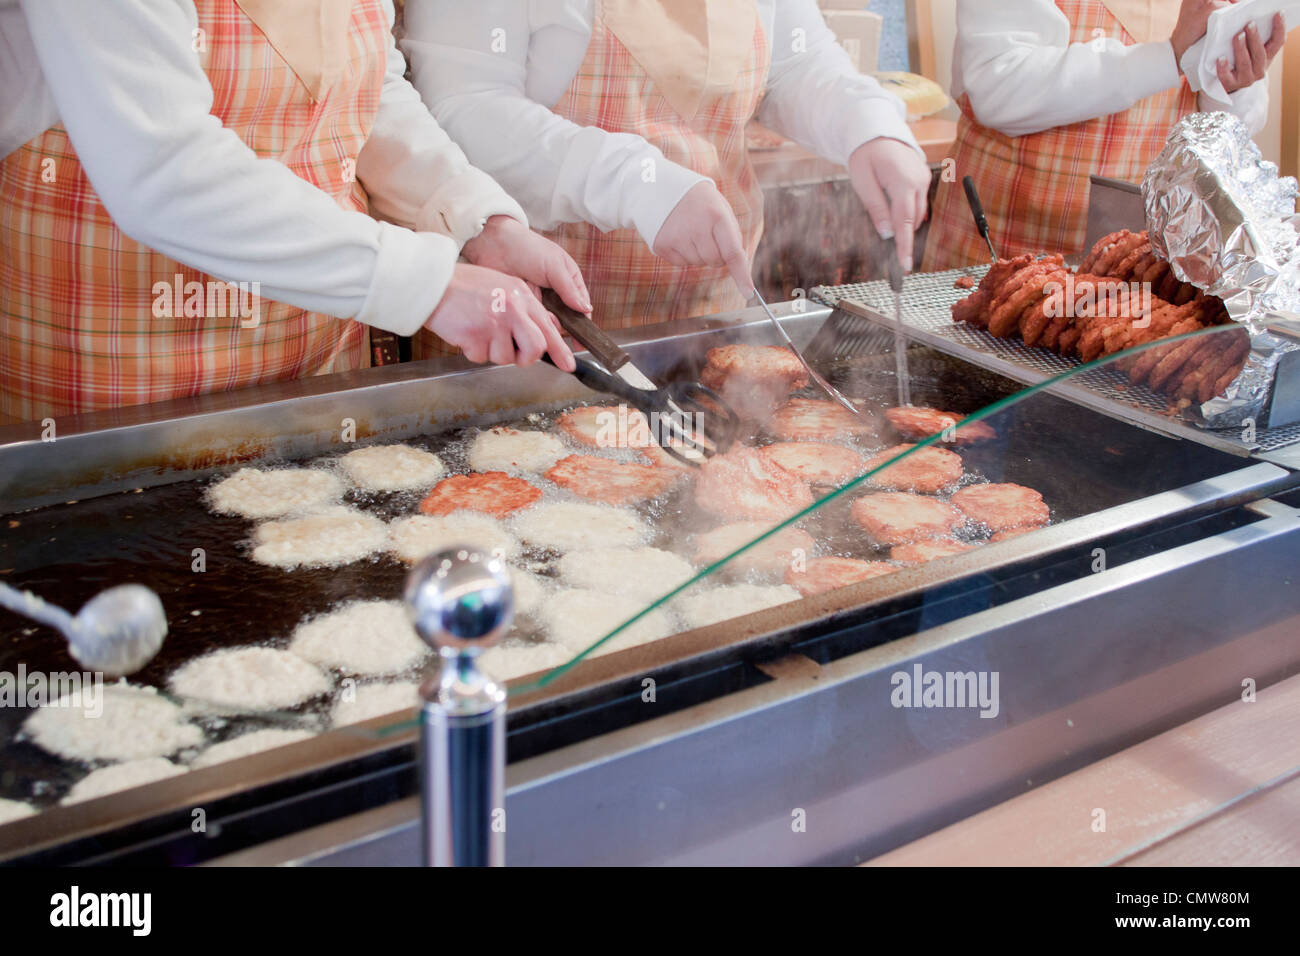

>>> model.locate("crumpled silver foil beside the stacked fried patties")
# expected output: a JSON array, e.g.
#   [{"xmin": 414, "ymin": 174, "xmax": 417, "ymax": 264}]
[{"xmin": 1143, "ymin": 113, "xmax": 1300, "ymax": 428}]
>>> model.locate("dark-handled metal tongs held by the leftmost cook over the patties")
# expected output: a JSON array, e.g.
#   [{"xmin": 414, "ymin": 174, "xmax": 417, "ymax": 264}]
[{"xmin": 542, "ymin": 289, "xmax": 740, "ymax": 468}]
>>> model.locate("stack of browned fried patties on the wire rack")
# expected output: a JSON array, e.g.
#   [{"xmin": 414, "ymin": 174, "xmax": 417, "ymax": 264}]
[{"xmin": 953, "ymin": 229, "xmax": 1251, "ymax": 410}]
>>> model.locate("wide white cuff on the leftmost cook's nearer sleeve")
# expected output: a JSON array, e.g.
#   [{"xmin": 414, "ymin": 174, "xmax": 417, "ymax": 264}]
[{"xmin": 356, "ymin": 222, "xmax": 460, "ymax": 336}]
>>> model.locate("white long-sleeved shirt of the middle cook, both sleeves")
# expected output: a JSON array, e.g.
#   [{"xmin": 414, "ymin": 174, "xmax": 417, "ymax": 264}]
[{"xmin": 402, "ymin": 0, "xmax": 920, "ymax": 247}]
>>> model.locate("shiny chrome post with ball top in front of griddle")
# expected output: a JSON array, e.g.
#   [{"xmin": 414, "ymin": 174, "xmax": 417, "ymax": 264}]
[{"xmin": 406, "ymin": 548, "xmax": 515, "ymax": 866}]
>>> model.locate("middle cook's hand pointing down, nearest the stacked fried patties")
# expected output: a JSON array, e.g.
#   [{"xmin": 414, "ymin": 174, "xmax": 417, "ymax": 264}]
[{"xmin": 849, "ymin": 138, "xmax": 930, "ymax": 272}]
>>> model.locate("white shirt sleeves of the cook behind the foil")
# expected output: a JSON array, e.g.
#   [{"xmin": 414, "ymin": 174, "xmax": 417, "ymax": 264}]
[{"xmin": 953, "ymin": 0, "xmax": 1269, "ymax": 137}]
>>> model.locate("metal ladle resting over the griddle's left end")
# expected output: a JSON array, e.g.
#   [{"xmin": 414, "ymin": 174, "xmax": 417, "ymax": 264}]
[{"xmin": 0, "ymin": 584, "xmax": 166, "ymax": 676}]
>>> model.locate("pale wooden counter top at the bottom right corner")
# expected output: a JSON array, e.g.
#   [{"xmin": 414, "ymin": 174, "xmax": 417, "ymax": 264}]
[{"xmin": 863, "ymin": 676, "xmax": 1300, "ymax": 866}]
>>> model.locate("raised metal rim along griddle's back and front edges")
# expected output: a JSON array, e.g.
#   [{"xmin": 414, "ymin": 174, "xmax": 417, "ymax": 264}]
[{"xmin": 0, "ymin": 302, "xmax": 1300, "ymax": 860}]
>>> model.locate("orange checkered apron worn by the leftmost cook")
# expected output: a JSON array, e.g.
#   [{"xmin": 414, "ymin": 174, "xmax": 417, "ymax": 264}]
[{"xmin": 0, "ymin": 0, "xmax": 389, "ymax": 421}]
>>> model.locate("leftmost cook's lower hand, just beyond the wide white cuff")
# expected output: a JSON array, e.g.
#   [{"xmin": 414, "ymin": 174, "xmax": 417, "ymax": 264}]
[{"xmin": 424, "ymin": 263, "xmax": 577, "ymax": 372}]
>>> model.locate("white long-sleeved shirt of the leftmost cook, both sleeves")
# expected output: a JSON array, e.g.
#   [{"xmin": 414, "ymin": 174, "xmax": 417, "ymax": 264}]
[{"xmin": 0, "ymin": 0, "xmax": 527, "ymax": 334}]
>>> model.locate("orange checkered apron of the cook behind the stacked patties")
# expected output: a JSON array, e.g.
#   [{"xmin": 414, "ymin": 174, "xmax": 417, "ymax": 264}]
[{"xmin": 922, "ymin": 0, "xmax": 1196, "ymax": 272}]
